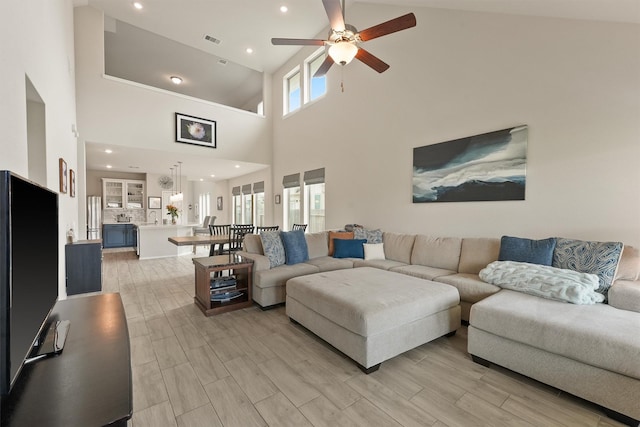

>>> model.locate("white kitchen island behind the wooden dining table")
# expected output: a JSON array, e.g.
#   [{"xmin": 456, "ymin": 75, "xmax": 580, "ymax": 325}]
[{"xmin": 136, "ymin": 223, "xmax": 199, "ymax": 259}]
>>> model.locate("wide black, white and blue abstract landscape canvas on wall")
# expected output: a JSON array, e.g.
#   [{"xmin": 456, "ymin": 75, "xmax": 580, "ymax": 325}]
[{"xmin": 413, "ymin": 126, "xmax": 528, "ymax": 203}]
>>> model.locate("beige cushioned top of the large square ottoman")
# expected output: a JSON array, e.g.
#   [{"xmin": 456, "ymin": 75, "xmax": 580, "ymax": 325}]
[{"xmin": 287, "ymin": 268, "xmax": 459, "ymax": 337}]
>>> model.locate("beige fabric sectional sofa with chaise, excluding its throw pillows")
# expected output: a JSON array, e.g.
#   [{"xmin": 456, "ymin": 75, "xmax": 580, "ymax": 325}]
[{"xmin": 240, "ymin": 232, "xmax": 640, "ymax": 426}]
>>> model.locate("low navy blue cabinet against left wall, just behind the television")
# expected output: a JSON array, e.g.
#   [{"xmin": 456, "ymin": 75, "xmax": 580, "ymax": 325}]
[{"xmin": 64, "ymin": 239, "xmax": 102, "ymax": 295}]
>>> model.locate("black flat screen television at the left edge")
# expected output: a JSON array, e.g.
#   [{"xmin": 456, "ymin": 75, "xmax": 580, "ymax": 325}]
[{"xmin": 0, "ymin": 171, "xmax": 59, "ymax": 396}]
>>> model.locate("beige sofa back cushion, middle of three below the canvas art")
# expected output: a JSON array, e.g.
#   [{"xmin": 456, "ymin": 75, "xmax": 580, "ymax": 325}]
[{"xmin": 411, "ymin": 235, "xmax": 462, "ymax": 272}]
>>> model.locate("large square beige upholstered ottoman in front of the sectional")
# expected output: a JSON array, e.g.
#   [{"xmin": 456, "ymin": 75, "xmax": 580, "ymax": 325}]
[{"xmin": 286, "ymin": 267, "xmax": 460, "ymax": 373}]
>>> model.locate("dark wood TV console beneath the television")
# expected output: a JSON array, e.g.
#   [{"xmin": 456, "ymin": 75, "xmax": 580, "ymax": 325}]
[{"xmin": 0, "ymin": 294, "xmax": 133, "ymax": 427}]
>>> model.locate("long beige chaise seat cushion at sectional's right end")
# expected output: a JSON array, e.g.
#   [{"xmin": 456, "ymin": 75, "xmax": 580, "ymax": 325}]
[{"xmin": 470, "ymin": 289, "xmax": 640, "ymax": 386}]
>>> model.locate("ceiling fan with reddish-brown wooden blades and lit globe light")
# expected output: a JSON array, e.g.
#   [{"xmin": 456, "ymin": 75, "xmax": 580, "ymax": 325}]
[{"xmin": 271, "ymin": 0, "xmax": 416, "ymax": 77}]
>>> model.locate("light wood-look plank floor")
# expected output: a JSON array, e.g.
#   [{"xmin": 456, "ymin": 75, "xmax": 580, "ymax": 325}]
[{"xmin": 103, "ymin": 248, "xmax": 621, "ymax": 427}]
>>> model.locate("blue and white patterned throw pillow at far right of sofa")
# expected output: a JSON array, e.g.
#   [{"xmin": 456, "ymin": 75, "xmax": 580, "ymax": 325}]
[{"xmin": 552, "ymin": 238, "xmax": 623, "ymax": 301}]
